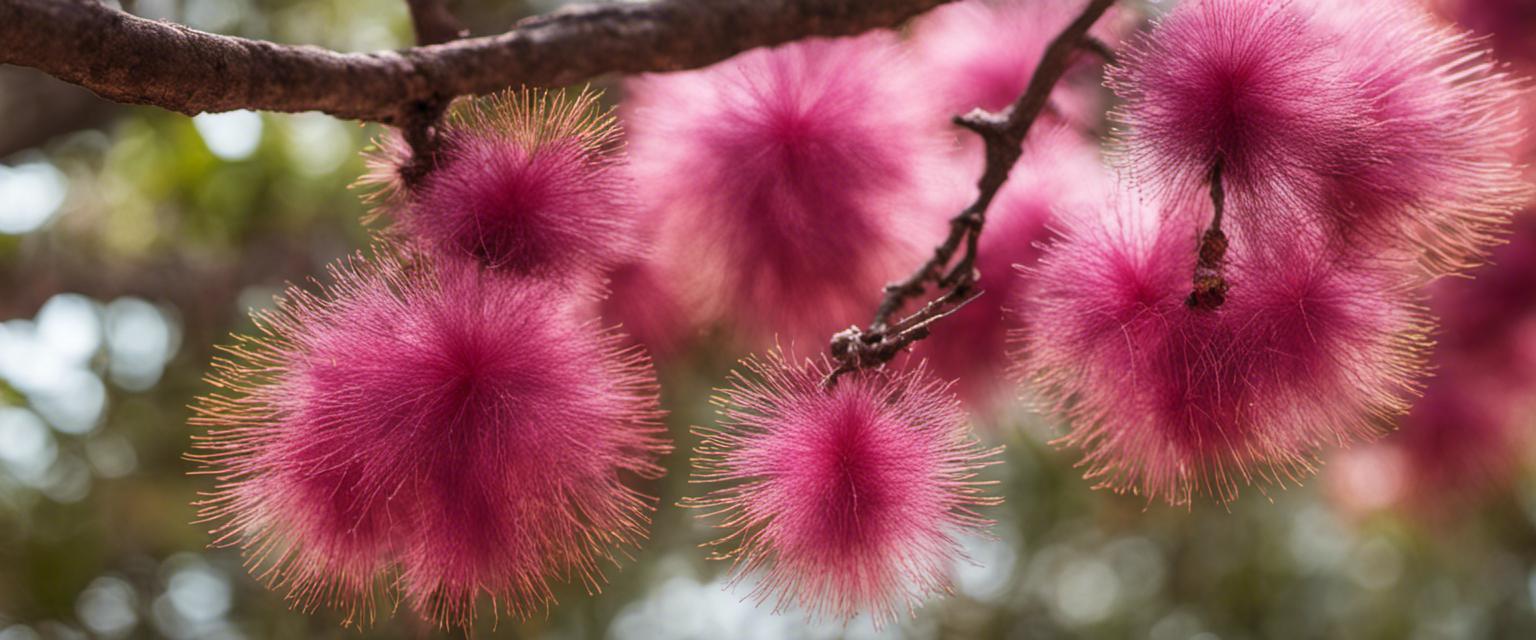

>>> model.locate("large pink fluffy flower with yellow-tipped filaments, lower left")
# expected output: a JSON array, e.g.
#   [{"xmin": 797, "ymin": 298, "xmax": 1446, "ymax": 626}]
[{"xmin": 189, "ymin": 247, "xmax": 670, "ymax": 628}]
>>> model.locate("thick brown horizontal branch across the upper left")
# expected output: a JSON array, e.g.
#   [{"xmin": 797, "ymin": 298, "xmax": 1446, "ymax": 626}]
[{"xmin": 0, "ymin": 0, "xmax": 951, "ymax": 124}]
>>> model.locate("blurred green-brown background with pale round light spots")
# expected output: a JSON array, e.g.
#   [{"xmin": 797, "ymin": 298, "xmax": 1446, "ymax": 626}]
[{"xmin": 0, "ymin": 0, "xmax": 1536, "ymax": 640}]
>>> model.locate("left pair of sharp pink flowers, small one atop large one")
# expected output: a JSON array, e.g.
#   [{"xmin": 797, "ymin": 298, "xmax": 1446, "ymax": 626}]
[{"xmin": 190, "ymin": 85, "xmax": 670, "ymax": 628}]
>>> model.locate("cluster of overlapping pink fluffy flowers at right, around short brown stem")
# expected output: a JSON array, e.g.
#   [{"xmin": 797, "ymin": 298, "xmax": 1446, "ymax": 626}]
[{"xmin": 1017, "ymin": 0, "xmax": 1528, "ymax": 503}]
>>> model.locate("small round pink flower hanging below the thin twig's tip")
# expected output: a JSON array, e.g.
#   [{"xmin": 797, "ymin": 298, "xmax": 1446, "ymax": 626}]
[{"xmin": 687, "ymin": 351, "xmax": 1000, "ymax": 625}]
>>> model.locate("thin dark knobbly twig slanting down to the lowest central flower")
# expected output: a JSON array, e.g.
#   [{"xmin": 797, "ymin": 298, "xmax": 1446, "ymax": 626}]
[{"xmin": 825, "ymin": 0, "xmax": 1115, "ymax": 387}]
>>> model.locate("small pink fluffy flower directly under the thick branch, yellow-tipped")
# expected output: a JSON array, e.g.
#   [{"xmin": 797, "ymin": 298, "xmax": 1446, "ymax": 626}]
[{"xmin": 361, "ymin": 91, "xmax": 642, "ymax": 278}]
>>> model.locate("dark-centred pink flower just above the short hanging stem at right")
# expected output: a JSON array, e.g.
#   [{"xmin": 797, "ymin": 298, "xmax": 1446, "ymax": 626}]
[{"xmin": 1107, "ymin": 0, "xmax": 1370, "ymax": 233}]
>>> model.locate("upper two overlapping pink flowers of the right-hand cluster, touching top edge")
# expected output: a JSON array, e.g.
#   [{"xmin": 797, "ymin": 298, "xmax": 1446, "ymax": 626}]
[{"xmin": 1111, "ymin": 0, "xmax": 1530, "ymax": 276}]
